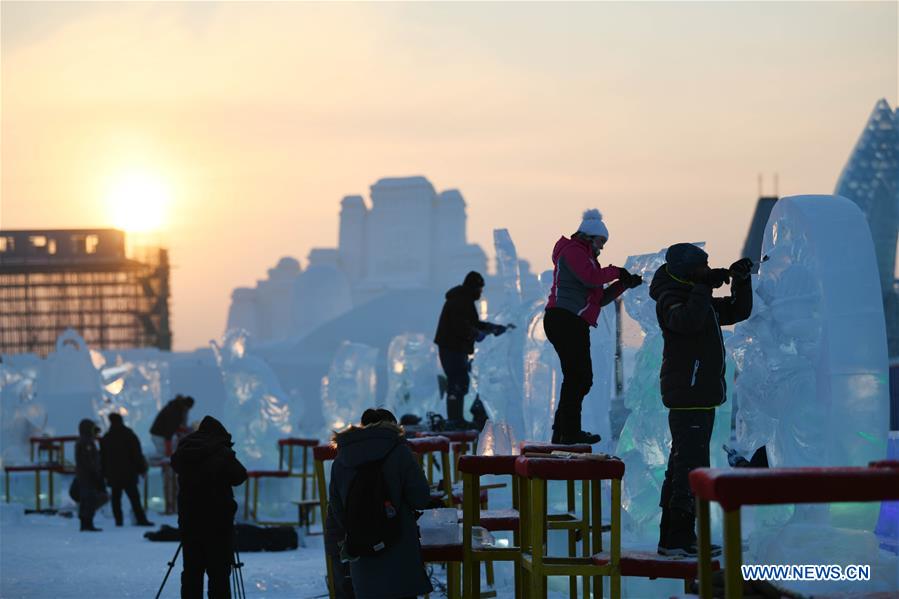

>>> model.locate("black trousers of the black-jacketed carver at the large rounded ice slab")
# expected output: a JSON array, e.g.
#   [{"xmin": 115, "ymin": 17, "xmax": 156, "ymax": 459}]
[{"xmin": 659, "ymin": 409, "xmax": 715, "ymax": 514}]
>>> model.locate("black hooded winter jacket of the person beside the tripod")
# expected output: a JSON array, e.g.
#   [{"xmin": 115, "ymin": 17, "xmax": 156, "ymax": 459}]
[{"xmin": 172, "ymin": 416, "xmax": 247, "ymax": 535}]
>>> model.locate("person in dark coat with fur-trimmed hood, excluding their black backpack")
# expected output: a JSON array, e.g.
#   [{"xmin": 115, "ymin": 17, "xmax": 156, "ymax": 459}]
[{"xmin": 328, "ymin": 410, "xmax": 433, "ymax": 599}]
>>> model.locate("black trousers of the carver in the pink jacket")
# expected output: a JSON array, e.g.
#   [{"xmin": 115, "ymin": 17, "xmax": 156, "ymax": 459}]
[{"xmin": 543, "ymin": 308, "xmax": 593, "ymax": 432}]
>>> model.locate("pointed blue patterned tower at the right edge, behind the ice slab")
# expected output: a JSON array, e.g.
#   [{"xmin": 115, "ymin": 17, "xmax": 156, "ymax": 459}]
[{"xmin": 836, "ymin": 99, "xmax": 899, "ymax": 356}]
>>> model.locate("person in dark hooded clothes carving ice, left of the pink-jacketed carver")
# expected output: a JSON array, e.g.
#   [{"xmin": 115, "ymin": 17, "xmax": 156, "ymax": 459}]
[{"xmin": 434, "ymin": 271, "xmax": 512, "ymax": 430}]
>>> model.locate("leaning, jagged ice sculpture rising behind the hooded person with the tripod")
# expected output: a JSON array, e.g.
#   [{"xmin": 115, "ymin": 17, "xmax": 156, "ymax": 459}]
[{"xmin": 210, "ymin": 329, "xmax": 299, "ymax": 466}]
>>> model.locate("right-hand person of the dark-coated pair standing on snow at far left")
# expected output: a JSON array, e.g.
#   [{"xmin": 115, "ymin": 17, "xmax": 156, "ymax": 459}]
[{"xmin": 100, "ymin": 412, "xmax": 153, "ymax": 526}]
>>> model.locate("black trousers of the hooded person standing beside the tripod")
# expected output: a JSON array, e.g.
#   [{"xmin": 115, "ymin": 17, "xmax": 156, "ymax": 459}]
[{"xmin": 181, "ymin": 534, "xmax": 234, "ymax": 599}]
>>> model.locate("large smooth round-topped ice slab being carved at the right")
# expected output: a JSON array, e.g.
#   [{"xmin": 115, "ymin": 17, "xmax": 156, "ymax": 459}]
[{"xmin": 731, "ymin": 196, "xmax": 889, "ymax": 466}]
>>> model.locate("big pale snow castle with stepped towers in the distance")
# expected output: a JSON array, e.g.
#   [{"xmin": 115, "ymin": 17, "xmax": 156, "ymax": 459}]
[{"xmin": 227, "ymin": 177, "xmax": 487, "ymax": 341}]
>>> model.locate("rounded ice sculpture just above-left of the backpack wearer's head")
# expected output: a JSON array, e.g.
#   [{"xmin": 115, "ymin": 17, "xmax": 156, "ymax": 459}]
[{"xmin": 322, "ymin": 341, "xmax": 378, "ymax": 438}]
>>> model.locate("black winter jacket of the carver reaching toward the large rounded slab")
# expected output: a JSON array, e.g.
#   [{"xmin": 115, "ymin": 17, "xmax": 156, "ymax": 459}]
[{"xmin": 649, "ymin": 264, "xmax": 752, "ymax": 409}]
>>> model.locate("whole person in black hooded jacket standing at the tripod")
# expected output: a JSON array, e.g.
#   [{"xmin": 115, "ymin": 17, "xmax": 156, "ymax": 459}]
[{"xmin": 172, "ymin": 416, "xmax": 247, "ymax": 599}]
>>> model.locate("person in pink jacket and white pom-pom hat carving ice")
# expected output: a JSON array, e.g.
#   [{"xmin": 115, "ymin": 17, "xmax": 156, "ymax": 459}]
[{"xmin": 543, "ymin": 209, "xmax": 643, "ymax": 445}]
